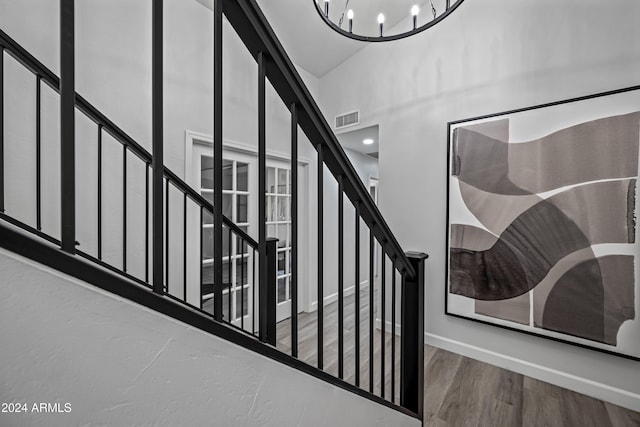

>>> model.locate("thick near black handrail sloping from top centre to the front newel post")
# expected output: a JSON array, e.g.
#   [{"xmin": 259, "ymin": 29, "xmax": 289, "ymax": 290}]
[{"xmin": 222, "ymin": 0, "xmax": 416, "ymax": 277}]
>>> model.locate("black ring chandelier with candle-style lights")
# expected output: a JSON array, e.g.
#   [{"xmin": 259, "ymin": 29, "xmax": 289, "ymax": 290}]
[{"xmin": 313, "ymin": 0, "xmax": 464, "ymax": 42}]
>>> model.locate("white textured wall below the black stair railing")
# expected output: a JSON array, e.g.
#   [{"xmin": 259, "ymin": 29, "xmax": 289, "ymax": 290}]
[{"xmin": 0, "ymin": 250, "xmax": 420, "ymax": 426}]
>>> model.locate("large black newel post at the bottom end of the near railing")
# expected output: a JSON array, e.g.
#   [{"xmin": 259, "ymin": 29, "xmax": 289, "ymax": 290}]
[{"xmin": 400, "ymin": 252, "xmax": 428, "ymax": 419}]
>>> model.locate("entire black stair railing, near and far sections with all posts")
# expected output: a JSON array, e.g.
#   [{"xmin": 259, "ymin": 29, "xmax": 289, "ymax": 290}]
[{"xmin": 0, "ymin": 0, "xmax": 426, "ymax": 418}]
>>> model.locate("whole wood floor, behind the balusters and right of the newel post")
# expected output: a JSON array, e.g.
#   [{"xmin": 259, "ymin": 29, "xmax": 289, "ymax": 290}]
[{"xmin": 277, "ymin": 290, "xmax": 640, "ymax": 427}]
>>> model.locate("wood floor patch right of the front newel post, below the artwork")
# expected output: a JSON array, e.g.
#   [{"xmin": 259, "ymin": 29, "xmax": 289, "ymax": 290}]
[{"xmin": 424, "ymin": 346, "xmax": 640, "ymax": 427}]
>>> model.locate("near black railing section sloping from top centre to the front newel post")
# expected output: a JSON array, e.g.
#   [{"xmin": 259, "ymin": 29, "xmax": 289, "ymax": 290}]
[{"xmin": 220, "ymin": 0, "xmax": 426, "ymax": 414}]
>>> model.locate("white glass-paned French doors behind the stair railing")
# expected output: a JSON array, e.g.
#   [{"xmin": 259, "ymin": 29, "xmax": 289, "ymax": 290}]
[{"xmin": 187, "ymin": 140, "xmax": 306, "ymax": 324}]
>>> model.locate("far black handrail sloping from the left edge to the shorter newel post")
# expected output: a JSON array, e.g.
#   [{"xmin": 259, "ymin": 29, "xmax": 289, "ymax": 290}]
[{"xmin": 0, "ymin": 29, "xmax": 258, "ymax": 248}]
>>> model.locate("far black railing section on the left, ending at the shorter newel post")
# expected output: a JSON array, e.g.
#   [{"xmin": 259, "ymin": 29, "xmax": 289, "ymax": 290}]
[{"xmin": 0, "ymin": 26, "xmax": 268, "ymax": 336}]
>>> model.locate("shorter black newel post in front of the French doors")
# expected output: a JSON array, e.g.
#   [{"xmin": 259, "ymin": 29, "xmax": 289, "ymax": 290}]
[{"xmin": 258, "ymin": 237, "xmax": 278, "ymax": 346}]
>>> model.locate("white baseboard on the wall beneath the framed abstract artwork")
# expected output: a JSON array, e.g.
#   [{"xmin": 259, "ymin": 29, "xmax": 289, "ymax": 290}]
[{"xmin": 424, "ymin": 333, "xmax": 640, "ymax": 411}]
